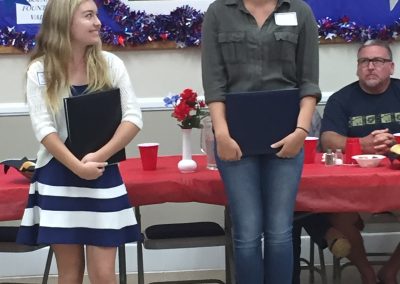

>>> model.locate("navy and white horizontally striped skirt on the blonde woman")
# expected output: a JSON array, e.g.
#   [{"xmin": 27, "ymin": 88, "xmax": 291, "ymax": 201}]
[{"xmin": 17, "ymin": 158, "xmax": 141, "ymax": 247}]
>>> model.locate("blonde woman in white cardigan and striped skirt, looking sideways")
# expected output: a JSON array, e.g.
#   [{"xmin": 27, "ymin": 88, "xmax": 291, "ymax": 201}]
[{"xmin": 18, "ymin": 0, "xmax": 142, "ymax": 283}]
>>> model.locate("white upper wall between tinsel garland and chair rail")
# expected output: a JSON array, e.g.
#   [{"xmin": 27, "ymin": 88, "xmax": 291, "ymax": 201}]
[{"xmin": 0, "ymin": 42, "xmax": 400, "ymax": 107}]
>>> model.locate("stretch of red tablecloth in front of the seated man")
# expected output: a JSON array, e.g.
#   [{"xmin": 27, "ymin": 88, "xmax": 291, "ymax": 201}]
[{"xmin": 296, "ymin": 159, "xmax": 400, "ymax": 212}]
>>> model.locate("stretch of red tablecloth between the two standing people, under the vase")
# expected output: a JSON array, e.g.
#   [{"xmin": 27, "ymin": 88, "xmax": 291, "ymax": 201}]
[{"xmin": 120, "ymin": 155, "xmax": 226, "ymax": 206}]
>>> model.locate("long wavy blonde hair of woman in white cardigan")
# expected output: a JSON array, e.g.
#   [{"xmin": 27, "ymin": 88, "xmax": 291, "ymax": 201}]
[{"xmin": 30, "ymin": 0, "xmax": 111, "ymax": 111}]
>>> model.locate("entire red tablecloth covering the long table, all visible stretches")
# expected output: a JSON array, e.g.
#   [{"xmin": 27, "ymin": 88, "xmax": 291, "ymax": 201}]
[{"xmin": 0, "ymin": 156, "xmax": 400, "ymax": 221}]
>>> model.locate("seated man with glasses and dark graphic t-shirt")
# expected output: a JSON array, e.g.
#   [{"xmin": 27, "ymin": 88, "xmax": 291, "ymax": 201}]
[{"xmin": 321, "ymin": 41, "xmax": 400, "ymax": 284}]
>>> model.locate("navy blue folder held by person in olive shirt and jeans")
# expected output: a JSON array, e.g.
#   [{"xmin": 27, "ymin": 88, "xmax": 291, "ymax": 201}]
[{"xmin": 225, "ymin": 89, "xmax": 300, "ymax": 156}]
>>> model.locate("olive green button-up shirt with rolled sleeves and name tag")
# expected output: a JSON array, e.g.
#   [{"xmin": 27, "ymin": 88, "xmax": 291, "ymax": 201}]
[{"xmin": 202, "ymin": 0, "xmax": 321, "ymax": 103}]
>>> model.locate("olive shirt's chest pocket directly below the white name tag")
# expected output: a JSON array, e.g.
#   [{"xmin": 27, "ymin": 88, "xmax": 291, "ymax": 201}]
[{"xmin": 269, "ymin": 31, "xmax": 298, "ymax": 61}]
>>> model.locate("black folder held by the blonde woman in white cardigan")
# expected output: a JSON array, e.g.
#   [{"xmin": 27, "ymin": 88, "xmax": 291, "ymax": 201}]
[{"xmin": 64, "ymin": 89, "xmax": 126, "ymax": 164}]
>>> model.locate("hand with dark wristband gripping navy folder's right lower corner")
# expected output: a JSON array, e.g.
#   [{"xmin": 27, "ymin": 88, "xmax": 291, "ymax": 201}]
[{"xmin": 271, "ymin": 129, "xmax": 307, "ymax": 158}]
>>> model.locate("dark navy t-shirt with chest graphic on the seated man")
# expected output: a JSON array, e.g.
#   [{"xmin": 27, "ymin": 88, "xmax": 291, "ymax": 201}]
[{"xmin": 321, "ymin": 78, "xmax": 400, "ymax": 137}]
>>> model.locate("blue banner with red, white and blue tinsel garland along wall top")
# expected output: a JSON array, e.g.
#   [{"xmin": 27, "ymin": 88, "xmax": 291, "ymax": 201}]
[{"xmin": 0, "ymin": 0, "xmax": 400, "ymax": 52}]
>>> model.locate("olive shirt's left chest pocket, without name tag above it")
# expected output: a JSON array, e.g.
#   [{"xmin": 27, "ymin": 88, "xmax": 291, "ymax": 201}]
[{"xmin": 218, "ymin": 32, "xmax": 247, "ymax": 64}]
